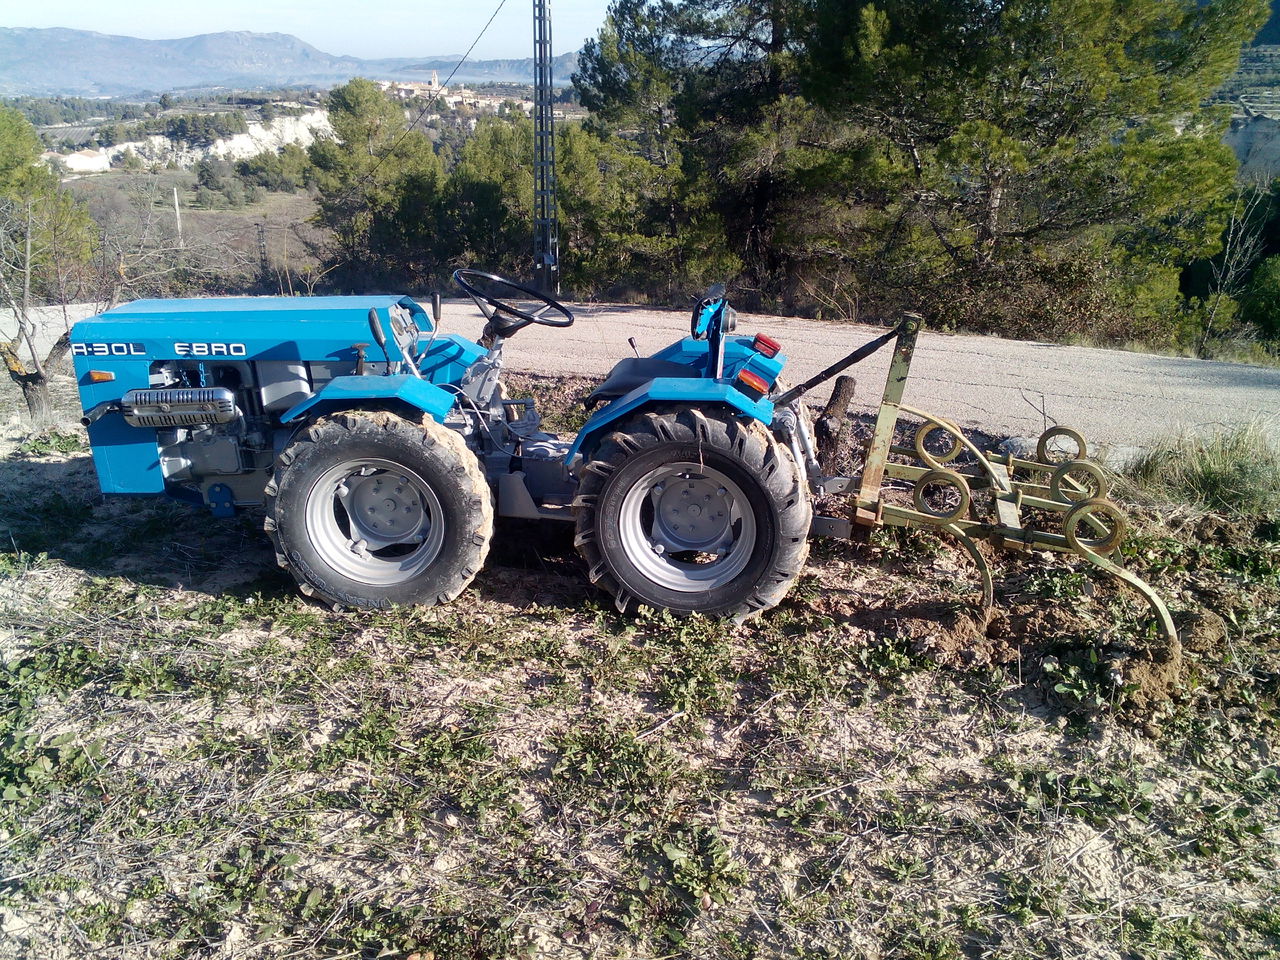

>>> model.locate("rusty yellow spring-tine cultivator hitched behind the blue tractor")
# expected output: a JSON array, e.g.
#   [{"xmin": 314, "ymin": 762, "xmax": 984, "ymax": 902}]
[{"xmin": 791, "ymin": 316, "xmax": 1176, "ymax": 647}]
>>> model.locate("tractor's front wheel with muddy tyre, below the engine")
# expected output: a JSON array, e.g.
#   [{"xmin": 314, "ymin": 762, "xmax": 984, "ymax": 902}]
[{"xmin": 265, "ymin": 411, "xmax": 493, "ymax": 608}]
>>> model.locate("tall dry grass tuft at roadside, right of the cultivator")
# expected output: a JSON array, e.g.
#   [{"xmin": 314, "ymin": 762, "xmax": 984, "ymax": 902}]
[{"xmin": 1125, "ymin": 421, "xmax": 1280, "ymax": 516}]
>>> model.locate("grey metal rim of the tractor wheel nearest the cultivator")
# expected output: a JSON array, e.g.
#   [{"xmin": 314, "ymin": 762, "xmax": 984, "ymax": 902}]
[{"xmin": 618, "ymin": 462, "xmax": 756, "ymax": 593}]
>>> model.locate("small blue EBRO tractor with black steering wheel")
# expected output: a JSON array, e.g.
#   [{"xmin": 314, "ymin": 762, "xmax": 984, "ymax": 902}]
[{"xmin": 72, "ymin": 270, "xmax": 813, "ymax": 617}]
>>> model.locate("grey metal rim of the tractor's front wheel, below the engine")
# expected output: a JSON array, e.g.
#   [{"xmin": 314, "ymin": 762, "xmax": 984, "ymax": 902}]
[{"xmin": 306, "ymin": 458, "xmax": 444, "ymax": 585}]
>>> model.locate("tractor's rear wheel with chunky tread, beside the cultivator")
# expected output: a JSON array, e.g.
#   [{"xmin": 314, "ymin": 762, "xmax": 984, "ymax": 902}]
[{"xmin": 573, "ymin": 408, "xmax": 813, "ymax": 621}]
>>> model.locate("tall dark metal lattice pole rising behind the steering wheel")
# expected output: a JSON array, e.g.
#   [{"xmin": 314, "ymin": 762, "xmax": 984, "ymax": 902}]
[{"xmin": 534, "ymin": 0, "xmax": 559, "ymax": 296}]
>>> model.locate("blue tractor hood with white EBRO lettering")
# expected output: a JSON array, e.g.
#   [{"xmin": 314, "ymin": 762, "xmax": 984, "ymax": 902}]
[{"xmin": 72, "ymin": 296, "xmax": 433, "ymax": 361}]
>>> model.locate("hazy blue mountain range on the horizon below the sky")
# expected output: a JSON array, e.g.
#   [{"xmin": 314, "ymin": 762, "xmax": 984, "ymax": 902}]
[{"xmin": 0, "ymin": 27, "xmax": 577, "ymax": 97}]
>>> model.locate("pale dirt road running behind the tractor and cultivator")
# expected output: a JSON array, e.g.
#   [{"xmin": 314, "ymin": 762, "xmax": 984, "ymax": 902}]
[{"xmin": 10, "ymin": 301, "xmax": 1280, "ymax": 452}]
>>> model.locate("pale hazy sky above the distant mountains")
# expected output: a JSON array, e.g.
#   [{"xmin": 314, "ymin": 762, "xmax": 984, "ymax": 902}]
[{"xmin": 0, "ymin": 0, "xmax": 608, "ymax": 60}]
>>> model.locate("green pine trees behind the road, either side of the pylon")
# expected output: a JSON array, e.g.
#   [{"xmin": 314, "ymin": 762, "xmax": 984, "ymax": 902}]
[{"xmin": 296, "ymin": 0, "xmax": 1280, "ymax": 353}]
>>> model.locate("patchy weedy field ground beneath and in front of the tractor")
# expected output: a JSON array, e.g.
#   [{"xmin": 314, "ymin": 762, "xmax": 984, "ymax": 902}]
[{"xmin": 0, "ymin": 385, "xmax": 1280, "ymax": 960}]
